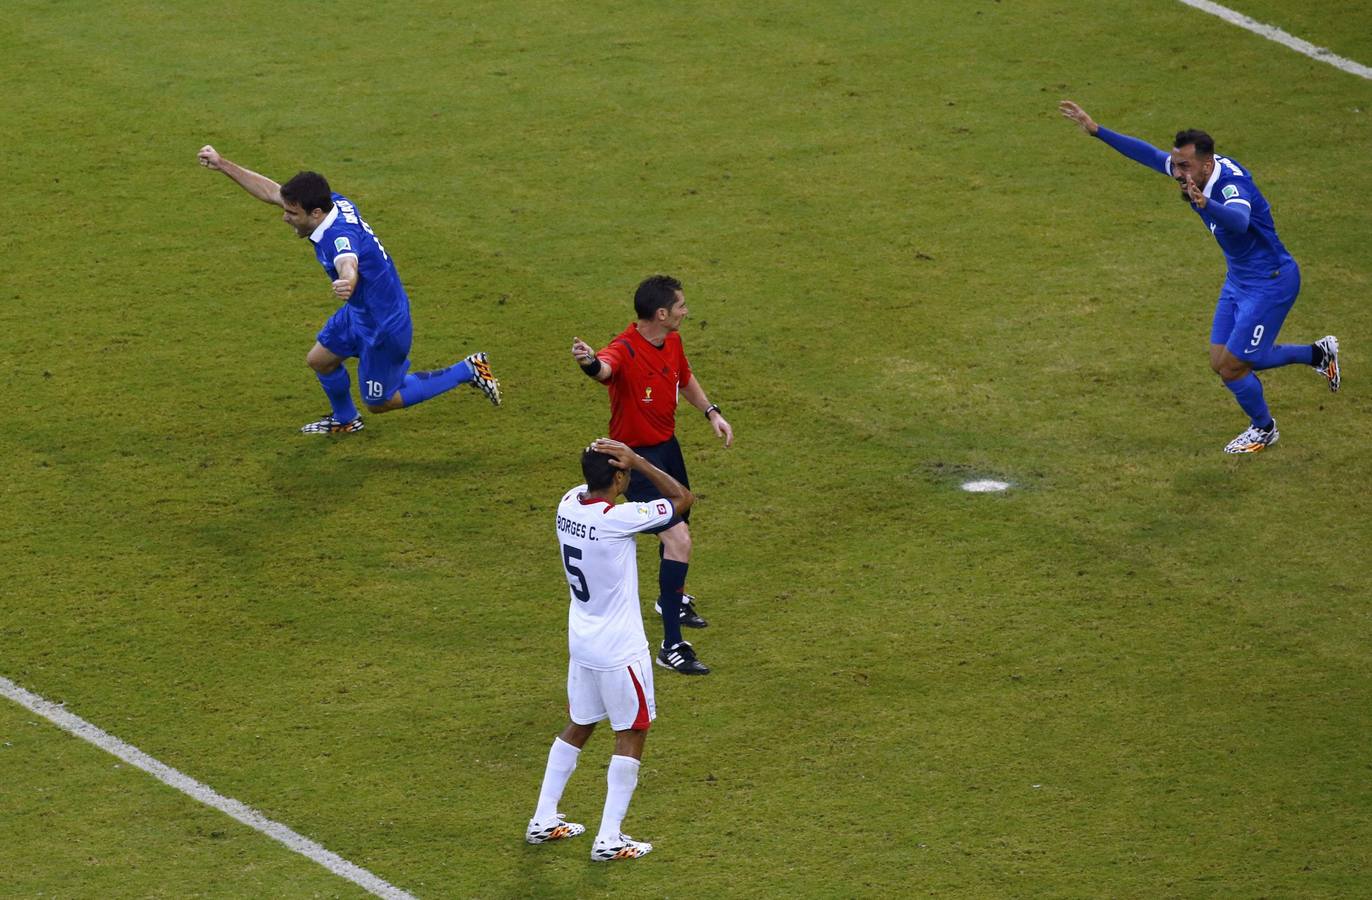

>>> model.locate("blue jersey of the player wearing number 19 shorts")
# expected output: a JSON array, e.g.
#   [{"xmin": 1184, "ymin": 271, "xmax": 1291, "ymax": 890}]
[{"xmin": 310, "ymin": 193, "xmax": 410, "ymax": 343}]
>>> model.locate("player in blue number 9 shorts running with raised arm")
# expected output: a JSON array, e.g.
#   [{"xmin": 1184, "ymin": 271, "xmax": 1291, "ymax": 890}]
[{"xmin": 1058, "ymin": 100, "xmax": 1340, "ymax": 453}]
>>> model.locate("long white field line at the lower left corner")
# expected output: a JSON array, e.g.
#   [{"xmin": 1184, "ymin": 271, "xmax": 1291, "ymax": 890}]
[{"xmin": 0, "ymin": 678, "xmax": 414, "ymax": 900}]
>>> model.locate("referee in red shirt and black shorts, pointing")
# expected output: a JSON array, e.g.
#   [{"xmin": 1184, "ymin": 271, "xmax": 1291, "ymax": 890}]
[{"xmin": 572, "ymin": 274, "xmax": 734, "ymax": 675}]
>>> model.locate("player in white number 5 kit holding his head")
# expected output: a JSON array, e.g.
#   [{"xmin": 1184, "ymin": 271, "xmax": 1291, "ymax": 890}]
[{"xmin": 524, "ymin": 439, "xmax": 696, "ymax": 862}]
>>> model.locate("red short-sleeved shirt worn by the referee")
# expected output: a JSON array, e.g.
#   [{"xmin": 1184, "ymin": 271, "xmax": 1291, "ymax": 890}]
[{"xmin": 595, "ymin": 322, "xmax": 690, "ymax": 447}]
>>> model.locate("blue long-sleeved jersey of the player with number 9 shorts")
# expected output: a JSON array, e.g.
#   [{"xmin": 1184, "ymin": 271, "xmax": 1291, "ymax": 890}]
[{"xmin": 1096, "ymin": 126, "xmax": 1295, "ymax": 285}]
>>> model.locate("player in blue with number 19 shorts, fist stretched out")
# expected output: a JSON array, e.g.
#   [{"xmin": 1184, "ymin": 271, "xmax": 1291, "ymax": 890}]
[{"xmin": 190, "ymin": 145, "xmax": 501, "ymax": 435}]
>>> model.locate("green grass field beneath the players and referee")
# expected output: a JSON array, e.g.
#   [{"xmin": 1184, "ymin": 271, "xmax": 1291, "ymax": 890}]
[{"xmin": 0, "ymin": 0, "xmax": 1372, "ymax": 897}]
